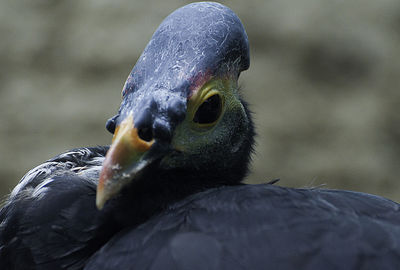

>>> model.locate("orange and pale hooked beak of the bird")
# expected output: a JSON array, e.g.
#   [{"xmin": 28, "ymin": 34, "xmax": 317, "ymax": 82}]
[{"xmin": 96, "ymin": 115, "xmax": 166, "ymax": 209}]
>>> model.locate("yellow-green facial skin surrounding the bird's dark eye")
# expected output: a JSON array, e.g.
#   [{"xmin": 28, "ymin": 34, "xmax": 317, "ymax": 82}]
[{"xmin": 160, "ymin": 79, "xmax": 249, "ymax": 171}]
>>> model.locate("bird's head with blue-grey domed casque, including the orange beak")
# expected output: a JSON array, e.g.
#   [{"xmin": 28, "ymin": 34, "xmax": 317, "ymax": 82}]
[{"xmin": 96, "ymin": 2, "xmax": 254, "ymax": 209}]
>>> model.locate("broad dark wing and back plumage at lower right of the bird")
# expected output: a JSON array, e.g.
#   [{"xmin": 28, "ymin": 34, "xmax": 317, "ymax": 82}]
[{"xmin": 85, "ymin": 185, "xmax": 400, "ymax": 270}]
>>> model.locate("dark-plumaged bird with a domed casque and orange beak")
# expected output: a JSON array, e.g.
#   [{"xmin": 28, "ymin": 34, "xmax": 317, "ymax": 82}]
[{"xmin": 0, "ymin": 2, "xmax": 400, "ymax": 270}]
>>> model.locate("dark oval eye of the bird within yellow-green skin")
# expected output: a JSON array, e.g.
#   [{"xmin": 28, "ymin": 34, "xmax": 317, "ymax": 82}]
[{"xmin": 193, "ymin": 95, "xmax": 222, "ymax": 124}]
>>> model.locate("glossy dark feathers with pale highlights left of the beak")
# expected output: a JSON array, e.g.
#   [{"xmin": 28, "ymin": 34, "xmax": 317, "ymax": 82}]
[{"xmin": 0, "ymin": 147, "xmax": 117, "ymax": 269}]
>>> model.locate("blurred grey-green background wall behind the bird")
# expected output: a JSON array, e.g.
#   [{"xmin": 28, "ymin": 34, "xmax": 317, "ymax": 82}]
[{"xmin": 0, "ymin": 0, "xmax": 400, "ymax": 201}]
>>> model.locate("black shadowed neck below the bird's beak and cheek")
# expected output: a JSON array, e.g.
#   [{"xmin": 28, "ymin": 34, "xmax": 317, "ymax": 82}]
[{"xmin": 111, "ymin": 99, "xmax": 255, "ymax": 226}]
